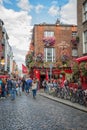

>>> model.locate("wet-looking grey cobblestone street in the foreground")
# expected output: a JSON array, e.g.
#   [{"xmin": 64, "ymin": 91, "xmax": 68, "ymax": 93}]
[{"xmin": 0, "ymin": 94, "xmax": 87, "ymax": 130}]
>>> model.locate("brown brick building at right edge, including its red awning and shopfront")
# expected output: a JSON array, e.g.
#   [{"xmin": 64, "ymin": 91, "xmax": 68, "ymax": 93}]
[{"xmin": 76, "ymin": 0, "xmax": 87, "ymax": 89}]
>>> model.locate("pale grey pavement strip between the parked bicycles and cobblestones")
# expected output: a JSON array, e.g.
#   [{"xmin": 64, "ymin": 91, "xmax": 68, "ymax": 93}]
[{"xmin": 39, "ymin": 90, "xmax": 87, "ymax": 112}]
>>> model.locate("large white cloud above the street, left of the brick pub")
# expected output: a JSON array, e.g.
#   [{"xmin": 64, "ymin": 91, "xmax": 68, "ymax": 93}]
[{"xmin": 0, "ymin": 5, "xmax": 32, "ymax": 66}]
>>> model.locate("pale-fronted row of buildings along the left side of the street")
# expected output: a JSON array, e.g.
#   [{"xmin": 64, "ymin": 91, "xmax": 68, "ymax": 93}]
[{"xmin": 0, "ymin": 19, "xmax": 13, "ymax": 75}]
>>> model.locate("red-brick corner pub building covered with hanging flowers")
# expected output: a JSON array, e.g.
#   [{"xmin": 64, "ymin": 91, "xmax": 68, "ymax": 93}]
[{"xmin": 26, "ymin": 23, "xmax": 78, "ymax": 81}]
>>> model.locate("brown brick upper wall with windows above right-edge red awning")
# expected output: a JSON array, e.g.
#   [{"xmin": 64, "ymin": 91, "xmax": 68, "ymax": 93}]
[{"xmin": 77, "ymin": 0, "xmax": 87, "ymax": 56}]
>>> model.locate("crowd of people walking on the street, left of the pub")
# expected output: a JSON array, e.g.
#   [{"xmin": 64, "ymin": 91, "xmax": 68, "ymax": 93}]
[{"xmin": 0, "ymin": 76, "xmax": 38, "ymax": 100}]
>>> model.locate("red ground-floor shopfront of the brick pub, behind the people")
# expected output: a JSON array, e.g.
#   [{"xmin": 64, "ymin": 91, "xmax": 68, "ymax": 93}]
[{"xmin": 32, "ymin": 68, "xmax": 72, "ymax": 87}]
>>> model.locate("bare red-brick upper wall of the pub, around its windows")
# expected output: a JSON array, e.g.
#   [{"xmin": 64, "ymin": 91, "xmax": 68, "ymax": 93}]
[{"xmin": 34, "ymin": 25, "xmax": 77, "ymax": 60}]
